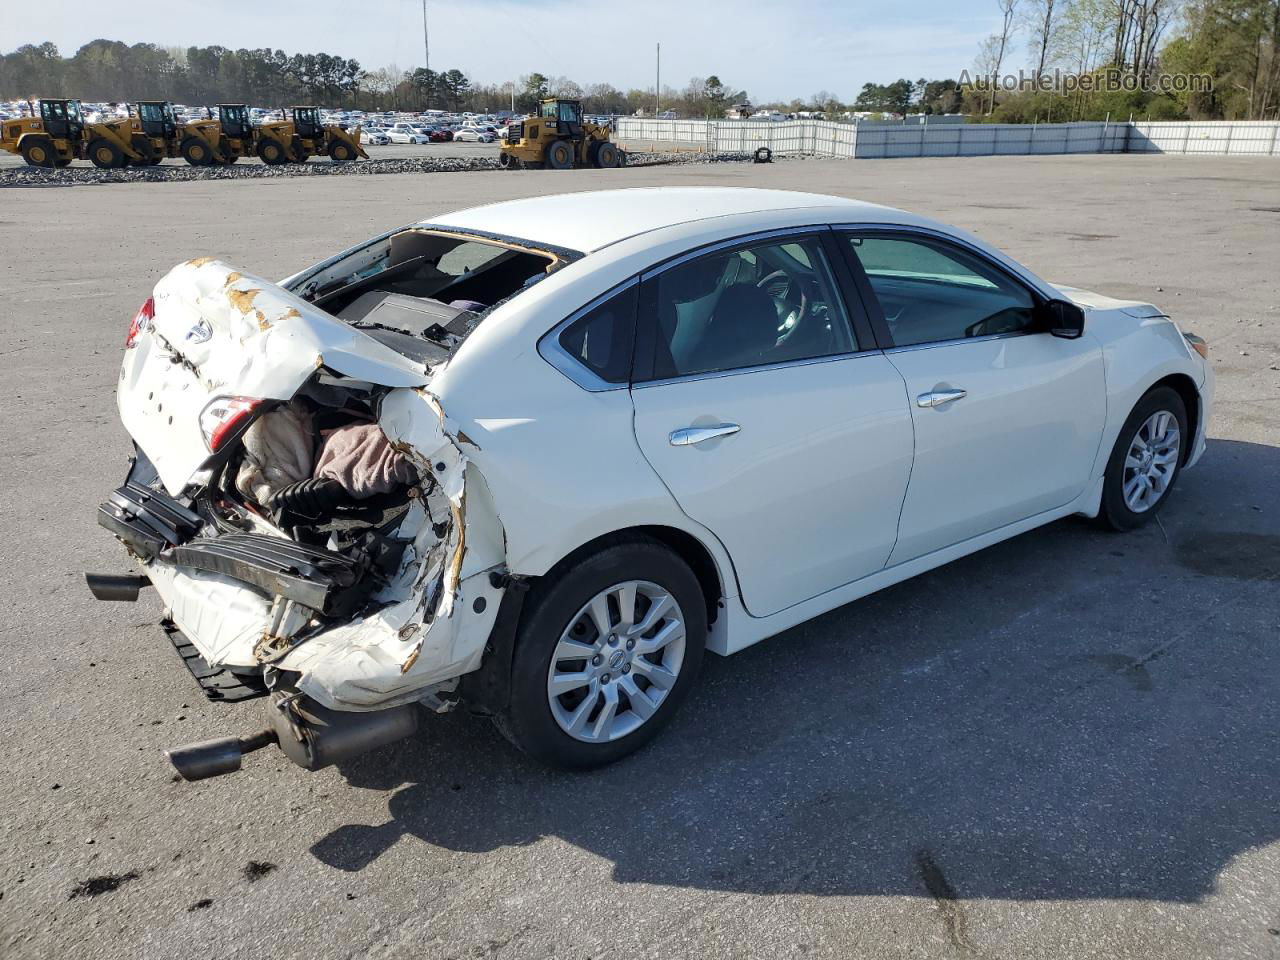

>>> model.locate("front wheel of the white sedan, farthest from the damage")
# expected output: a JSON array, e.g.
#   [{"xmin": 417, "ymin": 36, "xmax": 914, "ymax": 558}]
[{"xmin": 1102, "ymin": 387, "xmax": 1192, "ymax": 530}]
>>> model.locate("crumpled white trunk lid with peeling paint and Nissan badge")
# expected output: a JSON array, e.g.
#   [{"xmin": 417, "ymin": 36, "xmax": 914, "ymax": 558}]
[{"xmin": 125, "ymin": 257, "xmax": 430, "ymax": 495}]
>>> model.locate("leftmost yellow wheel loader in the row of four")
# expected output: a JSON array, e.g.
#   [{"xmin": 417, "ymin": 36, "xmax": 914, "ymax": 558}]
[{"xmin": 0, "ymin": 100, "xmax": 148, "ymax": 168}]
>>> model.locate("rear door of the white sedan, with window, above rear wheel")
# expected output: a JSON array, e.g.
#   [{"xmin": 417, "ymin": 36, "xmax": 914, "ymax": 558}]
[{"xmin": 631, "ymin": 229, "xmax": 911, "ymax": 617}]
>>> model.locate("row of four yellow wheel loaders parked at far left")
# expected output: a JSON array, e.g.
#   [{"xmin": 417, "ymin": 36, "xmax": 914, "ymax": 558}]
[{"xmin": 0, "ymin": 100, "xmax": 369, "ymax": 168}]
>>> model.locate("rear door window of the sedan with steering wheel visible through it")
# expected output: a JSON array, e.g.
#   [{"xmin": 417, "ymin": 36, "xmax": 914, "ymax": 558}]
[{"xmin": 646, "ymin": 237, "xmax": 856, "ymax": 380}]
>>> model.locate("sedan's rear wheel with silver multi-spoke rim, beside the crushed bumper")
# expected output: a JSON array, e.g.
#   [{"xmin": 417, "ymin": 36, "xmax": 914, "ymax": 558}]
[{"xmin": 495, "ymin": 540, "xmax": 707, "ymax": 769}]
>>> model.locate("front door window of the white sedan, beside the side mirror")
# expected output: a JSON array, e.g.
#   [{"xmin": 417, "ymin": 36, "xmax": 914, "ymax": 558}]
[{"xmin": 847, "ymin": 236, "xmax": 1036, "ymax": 347}]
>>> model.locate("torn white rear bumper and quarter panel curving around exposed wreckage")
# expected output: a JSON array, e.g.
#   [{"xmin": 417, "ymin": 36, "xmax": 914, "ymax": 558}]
[{"xmin": 135, "ymin": 389, "xmax": 504, "ymax": 710}]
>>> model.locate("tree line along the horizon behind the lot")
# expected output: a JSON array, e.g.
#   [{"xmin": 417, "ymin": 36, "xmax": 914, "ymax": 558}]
[{"xmin": 0, "ymin": 7, "xmax": 1280, "ymax": 123}]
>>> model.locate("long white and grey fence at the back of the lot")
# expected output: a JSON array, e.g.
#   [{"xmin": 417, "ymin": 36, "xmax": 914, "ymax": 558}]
[{"xmin": 617, "ymin": 116, "xmax": 1280, "ymax": 157}]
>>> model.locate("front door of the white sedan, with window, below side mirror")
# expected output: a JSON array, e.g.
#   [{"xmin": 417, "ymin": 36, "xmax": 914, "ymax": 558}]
[{"xmin": 841, "ymin": 232, "xmax": 1106, "ymax": 564}]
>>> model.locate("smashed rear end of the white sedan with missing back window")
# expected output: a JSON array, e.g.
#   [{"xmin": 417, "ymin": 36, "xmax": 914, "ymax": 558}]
[{"xmin": 88, "ymin": 227, "xmax": 562, "ymax": 780}]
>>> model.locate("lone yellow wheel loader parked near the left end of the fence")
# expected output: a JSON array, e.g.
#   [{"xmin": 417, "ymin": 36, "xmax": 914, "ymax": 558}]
[{"xmin": 498, "ymin": 97, "xmax": 625, "ymax": 170}]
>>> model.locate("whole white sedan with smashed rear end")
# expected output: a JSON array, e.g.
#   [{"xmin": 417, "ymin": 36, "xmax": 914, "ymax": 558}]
[{"xmin": 90, "ymin": 188, "xmax": 1213, "ymax": 780}]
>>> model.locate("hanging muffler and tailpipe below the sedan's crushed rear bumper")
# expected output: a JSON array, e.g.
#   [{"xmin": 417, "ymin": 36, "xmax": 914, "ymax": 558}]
[{"xmin": 165, "ymin": 692, "xmax": 419, "ymax": 781}]
